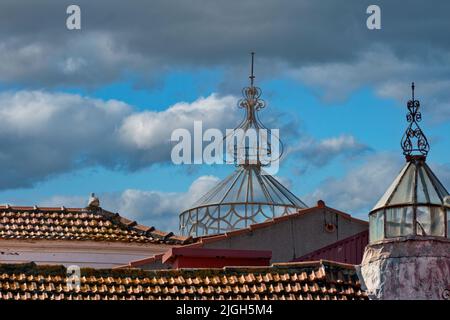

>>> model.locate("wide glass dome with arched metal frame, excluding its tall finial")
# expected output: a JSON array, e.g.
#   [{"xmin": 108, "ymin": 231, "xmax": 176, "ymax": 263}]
[{"xmin": 179, "ymin": 165, "xmax": 307, "ymax": 237}]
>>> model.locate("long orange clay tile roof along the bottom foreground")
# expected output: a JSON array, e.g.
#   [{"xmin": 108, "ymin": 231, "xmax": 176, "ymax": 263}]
[{"xmin": 0, "ymin": 260, "xmax": 367, "ymax": 300}]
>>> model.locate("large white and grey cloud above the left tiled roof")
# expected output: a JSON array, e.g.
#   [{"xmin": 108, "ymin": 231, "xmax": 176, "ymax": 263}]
[{"xmin": 0, "ymin": 91, "xmax": 239, "ymax": 189}]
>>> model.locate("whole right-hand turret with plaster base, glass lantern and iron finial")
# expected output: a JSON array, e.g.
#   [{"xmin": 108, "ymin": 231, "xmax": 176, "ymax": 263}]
[{"xmin": 361, "ymin": 83, "xmax": 450, "ymax": 299}]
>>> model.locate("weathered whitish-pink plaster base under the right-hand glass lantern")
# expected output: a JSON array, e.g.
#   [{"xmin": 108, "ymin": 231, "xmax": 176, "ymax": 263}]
[{"xmin": 360, "ymin": 237, "xmax": 450, "ymax": 300}]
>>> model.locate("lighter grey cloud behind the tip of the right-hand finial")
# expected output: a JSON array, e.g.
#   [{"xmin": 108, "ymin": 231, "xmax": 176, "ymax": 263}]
[{"xmin": 289, "ymin": 45, "xmax": 450, "ymax": 121}]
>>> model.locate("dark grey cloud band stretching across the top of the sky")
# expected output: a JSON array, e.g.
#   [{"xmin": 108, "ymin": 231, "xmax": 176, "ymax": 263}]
[{"xmin": 0, "ymin": 0, "xmax": 450, "ymax": 110}]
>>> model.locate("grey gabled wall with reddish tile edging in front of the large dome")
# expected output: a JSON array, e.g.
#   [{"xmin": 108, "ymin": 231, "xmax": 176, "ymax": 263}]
[{"xmin": 131, "ymin": 200, "xmax": 369, "ymax": 270}]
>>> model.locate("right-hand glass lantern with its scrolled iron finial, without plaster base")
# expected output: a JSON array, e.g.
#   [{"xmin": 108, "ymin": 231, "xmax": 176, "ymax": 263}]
[{"xmin": 369, "ymin": 83, "xmax": 450, "ymax": 242}]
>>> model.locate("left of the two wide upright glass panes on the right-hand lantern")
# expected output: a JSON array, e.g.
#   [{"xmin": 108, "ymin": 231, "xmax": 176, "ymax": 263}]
[{"xmin": 386, "ymin": 207, "xmax": 413, "ymax": 238}]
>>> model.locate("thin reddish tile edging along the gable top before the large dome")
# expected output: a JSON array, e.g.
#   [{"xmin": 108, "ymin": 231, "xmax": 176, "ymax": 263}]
[{"xmin": 183, "ymin": 200, "xmax": 369, "ymax": 247}]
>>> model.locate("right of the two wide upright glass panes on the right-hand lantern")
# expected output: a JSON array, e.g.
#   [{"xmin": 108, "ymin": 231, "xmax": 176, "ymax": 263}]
[{"xmin": 416, "ymin": 207, "xmax": 445, "ymax": 237}]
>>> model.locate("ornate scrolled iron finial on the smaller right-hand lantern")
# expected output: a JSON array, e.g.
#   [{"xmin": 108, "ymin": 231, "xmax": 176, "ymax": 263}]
[{"xmin": 401, "ymin": 82, "xmax": 430, "ymax": 159}]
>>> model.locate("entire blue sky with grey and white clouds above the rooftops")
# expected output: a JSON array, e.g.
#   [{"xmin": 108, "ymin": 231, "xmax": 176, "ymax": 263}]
[{"xmin": 0, "ymin": 0, "xmax": 450, "ymax": 230}]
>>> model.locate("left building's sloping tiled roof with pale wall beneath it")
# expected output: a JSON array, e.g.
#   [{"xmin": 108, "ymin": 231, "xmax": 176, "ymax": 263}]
[{"xmin": 0, "ymin": 204, "xmax": 192, "ymax": 268}]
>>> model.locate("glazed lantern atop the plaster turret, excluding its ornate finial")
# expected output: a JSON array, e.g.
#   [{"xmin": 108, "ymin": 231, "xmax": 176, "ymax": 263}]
[{"xmin": 369, "ymin": 156, "xmax": 450, "ymax": 243}]
